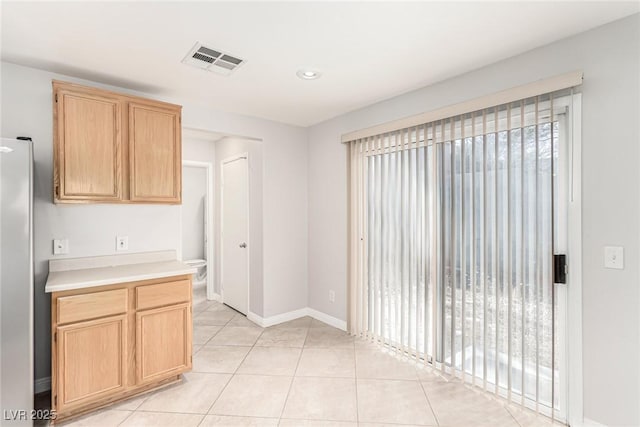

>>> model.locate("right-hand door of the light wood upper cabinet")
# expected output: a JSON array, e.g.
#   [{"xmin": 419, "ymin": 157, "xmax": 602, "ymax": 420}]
[{"xmin": 129, "ymin": 102, "xmax": 182, "ymax": 203}]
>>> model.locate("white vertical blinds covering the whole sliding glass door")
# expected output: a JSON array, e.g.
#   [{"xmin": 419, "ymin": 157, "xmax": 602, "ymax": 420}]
[{"xmin": 348, "ymin": 92, "xmax": 568, "ymax": 422}]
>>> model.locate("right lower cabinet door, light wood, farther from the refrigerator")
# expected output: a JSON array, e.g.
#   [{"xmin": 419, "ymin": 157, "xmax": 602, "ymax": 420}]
[{"xmin": 136, "ymin": 303, "xmax": 192, "ymax": 384}]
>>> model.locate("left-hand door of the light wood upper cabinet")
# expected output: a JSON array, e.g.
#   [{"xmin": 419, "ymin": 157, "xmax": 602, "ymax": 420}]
[{"xmin": 54, "ymin": 90, "xmax": 122, "ymax": 201}]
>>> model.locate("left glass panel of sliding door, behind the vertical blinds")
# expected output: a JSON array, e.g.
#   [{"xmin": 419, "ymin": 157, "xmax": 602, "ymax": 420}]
[{"xmin": 366, "ymin": 146, "xmax": 436, "ymax": 357}]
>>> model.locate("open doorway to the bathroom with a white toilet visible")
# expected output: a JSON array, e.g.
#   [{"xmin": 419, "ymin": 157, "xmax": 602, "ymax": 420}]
[{"xmin": 180, "ymin": 160, "xmax": 214, "ymax": 303}]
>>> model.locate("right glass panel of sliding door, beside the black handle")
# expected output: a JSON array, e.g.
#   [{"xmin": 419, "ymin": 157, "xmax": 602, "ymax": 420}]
[{"xmin": 437, "ymin": 109, "xmax": 560, "ymax": 407}]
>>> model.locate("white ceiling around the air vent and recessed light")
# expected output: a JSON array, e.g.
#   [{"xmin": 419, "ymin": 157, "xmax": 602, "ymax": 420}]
[{"xmin": 1, "ymin": 1, "xmax": 639, "ymax": 126}]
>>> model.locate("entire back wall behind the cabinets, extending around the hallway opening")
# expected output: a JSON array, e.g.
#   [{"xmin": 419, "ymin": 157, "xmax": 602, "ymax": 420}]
[{"xmin": 0, "ymin": 62, "xmax": 307, "ymax": 379}]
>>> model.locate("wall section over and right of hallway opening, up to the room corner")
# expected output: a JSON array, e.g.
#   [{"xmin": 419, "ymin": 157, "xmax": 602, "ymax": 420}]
[{"xmin": 176, "ymin": 104, "xmax": 308, "ymax": 324}]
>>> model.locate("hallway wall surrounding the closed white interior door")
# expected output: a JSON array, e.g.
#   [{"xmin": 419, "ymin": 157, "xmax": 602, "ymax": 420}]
[{"xmin": 214, "ymin": 137, "xmax": 264, "ymax": 316}]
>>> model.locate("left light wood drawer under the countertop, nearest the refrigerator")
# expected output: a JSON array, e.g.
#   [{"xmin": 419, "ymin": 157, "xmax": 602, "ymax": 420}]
[{"xmin": 58, "ymin": 289, "xmax": 127, "ymax": 325}]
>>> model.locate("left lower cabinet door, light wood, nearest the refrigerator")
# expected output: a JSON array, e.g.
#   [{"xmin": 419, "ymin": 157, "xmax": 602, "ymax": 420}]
[{"xmin": 56, "ymin": 315, "xmax": 127, "ymax": 412}]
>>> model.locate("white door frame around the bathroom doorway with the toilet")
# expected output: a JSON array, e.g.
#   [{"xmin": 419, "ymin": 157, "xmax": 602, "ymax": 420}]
[{"xmin": 178, "ymin": 160, "xmax": 216, "ymax": 300}]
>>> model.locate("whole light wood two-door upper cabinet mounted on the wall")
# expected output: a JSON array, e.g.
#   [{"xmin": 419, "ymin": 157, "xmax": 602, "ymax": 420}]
[{"xmin": 53, "ymin": 80, "xmax": 182, "ymax": 204}]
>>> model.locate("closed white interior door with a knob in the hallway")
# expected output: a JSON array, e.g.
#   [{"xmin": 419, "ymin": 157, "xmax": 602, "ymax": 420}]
[{"xmin": 221, "ymin": 156, "xmax": 249, "ymax": 314}]
